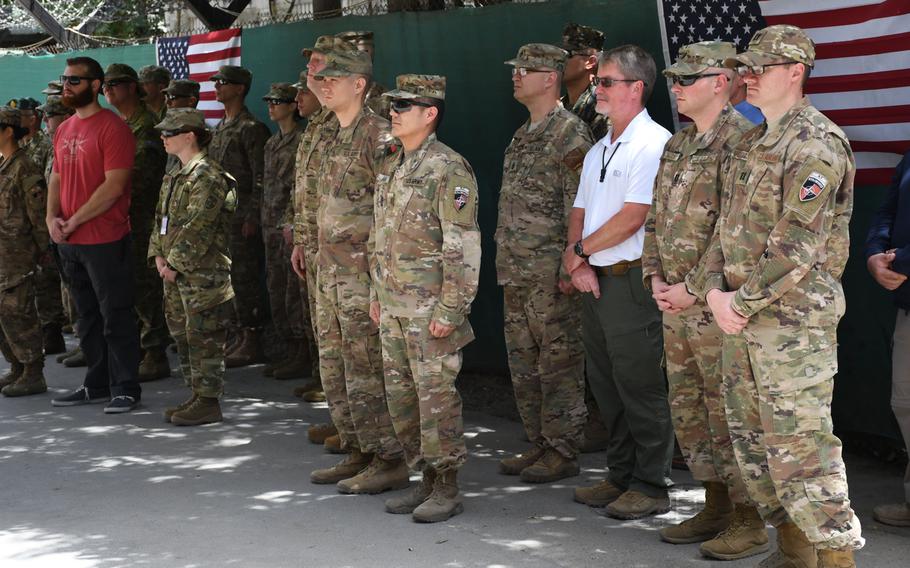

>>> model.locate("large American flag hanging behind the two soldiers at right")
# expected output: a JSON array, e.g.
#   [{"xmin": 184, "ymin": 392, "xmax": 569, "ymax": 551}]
[{"xmin": 658, "ymin": 0, "xmax": 910, "ymax": 185}]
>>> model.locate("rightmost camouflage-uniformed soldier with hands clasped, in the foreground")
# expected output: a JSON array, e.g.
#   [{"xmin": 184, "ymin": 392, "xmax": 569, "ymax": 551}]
[{"xmin": 693, "ymin": 25, "xmax": 864, "ymax": 568}]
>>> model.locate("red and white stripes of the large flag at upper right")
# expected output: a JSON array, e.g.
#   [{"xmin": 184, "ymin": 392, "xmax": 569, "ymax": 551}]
[{"xmin": 759, "ymin": 0, "xmax": 910, "ymax": 185}]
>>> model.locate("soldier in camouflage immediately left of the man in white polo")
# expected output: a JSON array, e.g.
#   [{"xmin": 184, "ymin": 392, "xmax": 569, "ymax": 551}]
[{"xmin": 496, "ymin": 43, "xmax": 594, "ymax": 483}]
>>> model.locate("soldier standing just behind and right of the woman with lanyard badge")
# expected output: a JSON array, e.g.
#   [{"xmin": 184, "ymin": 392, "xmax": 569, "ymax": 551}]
[{"xmin": 208, "ymin": 65, "xmax": 272, "ymax": 368}]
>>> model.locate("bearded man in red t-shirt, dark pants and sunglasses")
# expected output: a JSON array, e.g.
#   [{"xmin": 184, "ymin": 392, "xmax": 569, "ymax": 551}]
[{"xmin": 47, "ymin": 57, "xmax": 141, "ymax": 414}]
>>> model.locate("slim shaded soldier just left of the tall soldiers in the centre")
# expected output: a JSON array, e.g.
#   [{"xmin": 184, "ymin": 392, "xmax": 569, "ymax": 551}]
[{"xmin": 260, "ymin": 83, "xmax": 312, "ymax": 379}]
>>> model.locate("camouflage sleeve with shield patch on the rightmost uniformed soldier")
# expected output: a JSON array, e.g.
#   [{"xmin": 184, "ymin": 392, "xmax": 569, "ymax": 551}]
[{"xmin": 733, "ymin": 139, "xmax": 852, "ymax": 317}]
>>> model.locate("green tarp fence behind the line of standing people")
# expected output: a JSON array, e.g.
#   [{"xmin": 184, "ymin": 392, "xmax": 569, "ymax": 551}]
[{"xmin": 0, "ymin": 0, "xmax": 900, "ymax": 440}]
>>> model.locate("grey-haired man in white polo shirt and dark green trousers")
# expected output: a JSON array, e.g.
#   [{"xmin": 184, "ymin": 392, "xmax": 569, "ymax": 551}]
[{"xmin": 563, "ymin": 45, "xmax": 673, "ymax": 519}]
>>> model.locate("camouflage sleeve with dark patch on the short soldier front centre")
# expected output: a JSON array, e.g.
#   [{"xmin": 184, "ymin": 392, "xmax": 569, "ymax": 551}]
[{"xmin": 433, "ymin": 162, "xmax": 480, "ymax": 326}]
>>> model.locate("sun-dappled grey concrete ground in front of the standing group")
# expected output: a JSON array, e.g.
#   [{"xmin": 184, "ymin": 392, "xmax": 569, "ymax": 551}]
[{"xmin": 0, "ymin": 342, "xmax": 910, "ymax": 568}]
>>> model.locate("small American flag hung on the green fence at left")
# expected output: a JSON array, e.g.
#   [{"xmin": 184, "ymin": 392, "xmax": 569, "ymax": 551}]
[{"xmin": 157, "ymin": 28, "xmax": 241, "ymax": 126}]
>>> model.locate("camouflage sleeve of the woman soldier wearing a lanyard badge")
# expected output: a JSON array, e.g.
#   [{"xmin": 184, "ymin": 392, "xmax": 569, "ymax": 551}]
[{"xmin": 167, "ymin": 170, "xmax": 231, "ymax": 273}]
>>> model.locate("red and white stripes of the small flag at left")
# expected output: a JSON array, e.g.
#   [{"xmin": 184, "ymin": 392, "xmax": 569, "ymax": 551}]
[{"xmin": 186, "ymin": 28, "xmax": 241, "ymax": 126}]
